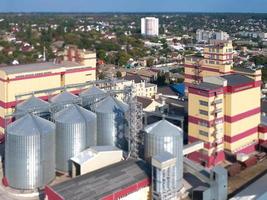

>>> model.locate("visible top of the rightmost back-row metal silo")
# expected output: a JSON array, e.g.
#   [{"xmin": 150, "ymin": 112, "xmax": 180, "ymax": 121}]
[{"xmin": 80, "ymin": 86, "xmax": 107, "ymax": 110}]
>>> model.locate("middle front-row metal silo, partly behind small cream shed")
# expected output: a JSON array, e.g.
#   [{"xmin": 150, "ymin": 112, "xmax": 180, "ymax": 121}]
[{"xmin": 54, "ymin": 105, "xmax": 96, "ymax": 172}]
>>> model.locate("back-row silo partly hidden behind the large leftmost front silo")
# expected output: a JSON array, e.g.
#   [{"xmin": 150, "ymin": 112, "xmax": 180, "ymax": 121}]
[{"xmin": 15, "ymin": 96, "xmax": 50, "ymax": 119}]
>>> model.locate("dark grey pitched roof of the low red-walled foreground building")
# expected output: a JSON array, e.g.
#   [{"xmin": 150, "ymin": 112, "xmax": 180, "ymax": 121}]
[{"xmin": 51, "ymin": 159, "xmax": 150, "ymax": 200}]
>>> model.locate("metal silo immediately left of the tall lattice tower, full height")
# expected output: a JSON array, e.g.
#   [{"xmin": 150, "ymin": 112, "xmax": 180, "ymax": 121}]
[{"xmin": 95, "ymin": 96, "xmax": 129, "ymax": 150}]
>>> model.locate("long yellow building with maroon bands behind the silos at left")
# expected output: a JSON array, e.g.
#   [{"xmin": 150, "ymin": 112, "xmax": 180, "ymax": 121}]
[{"xmin": 0, "ymin": 46, "xmax": 96, "ymax": 133}]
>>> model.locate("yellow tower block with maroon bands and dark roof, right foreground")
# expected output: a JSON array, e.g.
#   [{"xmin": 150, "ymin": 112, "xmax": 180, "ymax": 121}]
[{"xmin": 188, "ymin": 71, "xmax": 264, "ymax": 167}]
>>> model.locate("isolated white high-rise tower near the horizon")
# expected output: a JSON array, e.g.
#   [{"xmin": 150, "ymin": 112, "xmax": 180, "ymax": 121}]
[{"xmin": 141, "ymin": 17, "xmax": 159, "ymax": 36}]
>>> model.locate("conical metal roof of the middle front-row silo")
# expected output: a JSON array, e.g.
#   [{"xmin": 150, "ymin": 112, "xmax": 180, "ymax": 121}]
[{"xmin": 54, "ymin": 105, "xmax": 96, "ymax": 123}]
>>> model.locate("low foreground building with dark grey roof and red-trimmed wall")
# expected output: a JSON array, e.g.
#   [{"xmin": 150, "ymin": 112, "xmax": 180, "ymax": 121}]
[{"xmin": 45, "ymin": 159, "xmax": 150, "ymax": 200}]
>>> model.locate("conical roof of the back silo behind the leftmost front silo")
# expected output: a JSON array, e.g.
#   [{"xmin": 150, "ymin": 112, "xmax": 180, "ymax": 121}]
[{"xmin": 16, "ymin": 96, "xmax": 49, "ymax": 111}]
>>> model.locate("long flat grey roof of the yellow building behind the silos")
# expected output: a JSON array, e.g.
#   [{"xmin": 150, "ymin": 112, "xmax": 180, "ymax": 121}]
[{"xmin": 0, "ymin": 61, "xmax": 81, "ymax": 74}]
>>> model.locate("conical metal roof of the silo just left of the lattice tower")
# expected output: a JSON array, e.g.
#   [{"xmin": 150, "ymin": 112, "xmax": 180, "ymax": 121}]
[{"xmin": 95, "ymin": 96, "xmax": 129, "ymax": 113}]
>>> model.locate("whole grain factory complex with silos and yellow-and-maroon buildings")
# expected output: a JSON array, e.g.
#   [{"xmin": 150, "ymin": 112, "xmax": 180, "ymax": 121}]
[{"xmin": 0, "ymin": 41, "xmax": 267, "ymax": 200}]
